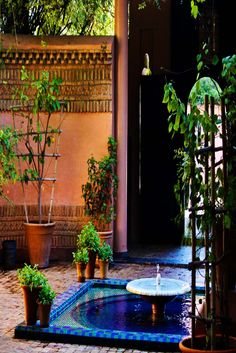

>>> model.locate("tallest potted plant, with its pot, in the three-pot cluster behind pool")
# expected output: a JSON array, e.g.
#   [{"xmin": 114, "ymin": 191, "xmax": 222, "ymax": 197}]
[{"xmin": 77, "ymin": 221, "xmax": 100, "ymax": 279}]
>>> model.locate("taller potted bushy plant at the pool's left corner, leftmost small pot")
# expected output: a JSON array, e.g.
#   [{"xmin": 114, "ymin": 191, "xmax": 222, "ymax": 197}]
[{"xmin": 17, "ymin": 264, "xmax": 47, "ymax": 325}]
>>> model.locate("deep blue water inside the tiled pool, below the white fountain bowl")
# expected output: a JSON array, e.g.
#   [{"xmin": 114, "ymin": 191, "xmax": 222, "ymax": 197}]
[{"xmin": 52, "ymin": 286, "xmax": 190, "ymax": 335}]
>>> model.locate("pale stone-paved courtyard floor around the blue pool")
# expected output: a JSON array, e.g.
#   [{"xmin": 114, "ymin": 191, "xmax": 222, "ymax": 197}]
[{"xmin": 0, "ymin": 249, "xmax": 202, "ymax": 353}]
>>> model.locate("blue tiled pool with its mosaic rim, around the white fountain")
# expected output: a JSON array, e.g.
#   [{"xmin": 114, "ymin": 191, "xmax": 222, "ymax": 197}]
[{"xmin": 15, "ymin": 279, "xmax": 195, "ymax": 351}]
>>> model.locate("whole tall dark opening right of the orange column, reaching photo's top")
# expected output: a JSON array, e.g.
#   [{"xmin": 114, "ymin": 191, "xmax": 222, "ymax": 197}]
[{"xmin": 128, "ymin": 0, "xmax": 235, "ymax": 249}]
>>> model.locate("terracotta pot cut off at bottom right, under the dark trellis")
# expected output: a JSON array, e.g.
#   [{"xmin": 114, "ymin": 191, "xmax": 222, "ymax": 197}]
[{"xmin": 179, "ymin": 335, "xmax": 236, "ymax": 353}]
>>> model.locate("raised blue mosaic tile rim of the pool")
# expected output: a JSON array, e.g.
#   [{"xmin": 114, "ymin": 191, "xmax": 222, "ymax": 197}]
[{"xmin": 15, "ymin": 279, "xmax": 203, "ymax": 352}]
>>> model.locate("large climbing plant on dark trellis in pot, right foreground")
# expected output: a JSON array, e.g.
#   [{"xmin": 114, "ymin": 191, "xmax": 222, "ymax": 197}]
[{"xmin": 163, "ymin": 50, "xmax": 236, "ymax": 352}]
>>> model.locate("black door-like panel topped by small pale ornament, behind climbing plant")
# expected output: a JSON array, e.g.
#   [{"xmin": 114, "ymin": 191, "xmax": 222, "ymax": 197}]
[{"xmin": 138, "ymin": 72, "xmax": 193, "ymax": 245}]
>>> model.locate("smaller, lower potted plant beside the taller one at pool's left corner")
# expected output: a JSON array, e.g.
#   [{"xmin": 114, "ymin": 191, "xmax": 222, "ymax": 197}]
[{"xmin": 37, "ymin": 283, "xmax": 56, "ymax": 327}]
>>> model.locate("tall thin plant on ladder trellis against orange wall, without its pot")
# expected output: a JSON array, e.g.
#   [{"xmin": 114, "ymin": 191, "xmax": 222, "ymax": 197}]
[{"xmin": 12, "ymin": 67, "xmax": 62, "ymax": 223}]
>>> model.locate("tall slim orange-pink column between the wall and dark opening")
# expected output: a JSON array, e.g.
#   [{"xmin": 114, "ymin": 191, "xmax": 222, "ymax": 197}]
[{"xmin": 114, "ymin": 0, "xmax": 128, "ymax": 254}]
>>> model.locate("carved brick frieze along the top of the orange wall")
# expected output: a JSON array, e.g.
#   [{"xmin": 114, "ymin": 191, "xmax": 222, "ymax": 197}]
[{"xmin": 0, "ymin": 47, "xmax": 112, "ymax": 112}]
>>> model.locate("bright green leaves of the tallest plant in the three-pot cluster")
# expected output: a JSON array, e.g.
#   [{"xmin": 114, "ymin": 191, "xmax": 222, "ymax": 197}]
[{"xmin": 77, "ymin": 222, "xmax": 100, "ymax": 252}]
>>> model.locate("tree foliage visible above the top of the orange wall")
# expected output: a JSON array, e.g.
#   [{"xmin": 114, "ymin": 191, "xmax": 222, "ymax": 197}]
[{"xmin": 0, "ymin": 0, "xmax": 114, "ymax": 35}]
